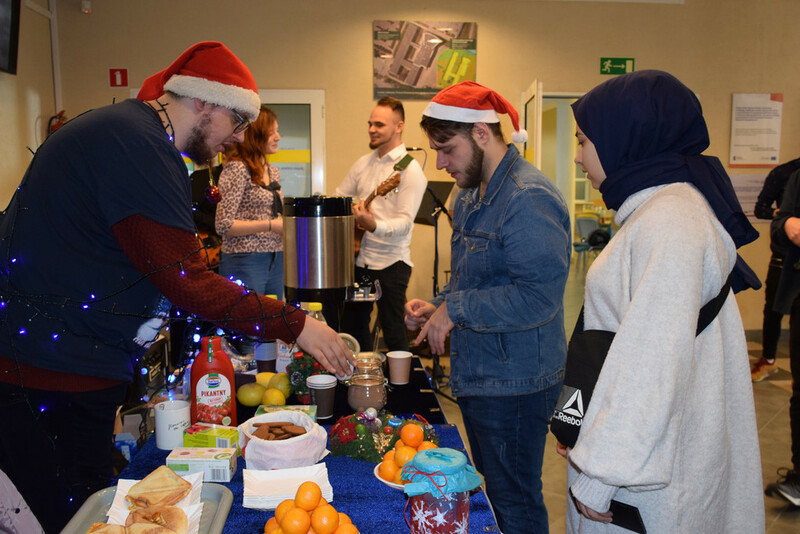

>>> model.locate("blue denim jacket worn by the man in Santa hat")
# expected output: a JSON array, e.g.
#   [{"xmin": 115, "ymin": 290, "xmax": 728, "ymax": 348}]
[{"xmin": 431, "ymin": 145, "xmax": 572, "ymax": 396}]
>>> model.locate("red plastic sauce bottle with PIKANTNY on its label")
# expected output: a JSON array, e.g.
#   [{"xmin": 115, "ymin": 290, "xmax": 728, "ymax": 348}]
[{"xmin": 192, "ymin": 336, "xmax": 236, "ymax": 426}]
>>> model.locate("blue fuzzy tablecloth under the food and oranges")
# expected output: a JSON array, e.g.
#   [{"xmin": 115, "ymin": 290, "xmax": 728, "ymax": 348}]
[{"xmin": 120, "ymin": 424, "xmax": 499, "ymax": 534}]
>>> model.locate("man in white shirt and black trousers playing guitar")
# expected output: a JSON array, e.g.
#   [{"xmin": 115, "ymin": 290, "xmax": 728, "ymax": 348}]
[{"xmin": 336, "ymin": 97, "xmax": 428, "ymax": 351}]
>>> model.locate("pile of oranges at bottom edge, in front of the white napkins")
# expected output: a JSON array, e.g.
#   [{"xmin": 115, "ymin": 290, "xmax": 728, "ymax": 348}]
[{"xmin": 264, "ymin": 480, "xmax": 358, "ymax": 534}]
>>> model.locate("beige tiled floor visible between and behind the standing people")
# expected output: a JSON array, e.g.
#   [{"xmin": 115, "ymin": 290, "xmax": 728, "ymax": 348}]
[{"xmin": 426, "ymin": 258, "xmax": 800, "ymax": 534}]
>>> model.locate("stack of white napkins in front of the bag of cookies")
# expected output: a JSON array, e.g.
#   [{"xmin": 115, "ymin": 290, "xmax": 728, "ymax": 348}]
[{"xmin": 242, "ymin": 464, "xmax": 333, "ymax": 510}]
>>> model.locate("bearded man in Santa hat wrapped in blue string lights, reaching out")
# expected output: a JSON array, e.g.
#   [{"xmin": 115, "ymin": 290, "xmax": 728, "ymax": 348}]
[{"xmin": 0, "ymin": 42, "xmax": 353, "ymax": 532}]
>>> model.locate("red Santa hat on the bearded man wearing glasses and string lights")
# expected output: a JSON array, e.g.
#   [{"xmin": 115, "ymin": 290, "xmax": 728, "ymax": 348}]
[{"xmin": 136, "ymin": 41, "xmax": 261, "ymax": 121}]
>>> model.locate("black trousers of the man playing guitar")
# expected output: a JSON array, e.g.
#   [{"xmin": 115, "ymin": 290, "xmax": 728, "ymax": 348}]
[{"xmin": 342, "ymin": 261, "xmax": 411, "ymax": 352}]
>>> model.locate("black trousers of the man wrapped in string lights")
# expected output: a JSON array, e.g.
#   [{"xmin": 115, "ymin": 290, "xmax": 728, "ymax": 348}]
[{"xmin": 0, "ymin": 382, "xmax": 127, "ymax": 533}]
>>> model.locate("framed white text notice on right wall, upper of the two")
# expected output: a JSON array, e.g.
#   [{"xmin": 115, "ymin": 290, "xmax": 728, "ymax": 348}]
[{"xmin": 729, "ymin": 93, "xmax": 783, "ymax": 167}]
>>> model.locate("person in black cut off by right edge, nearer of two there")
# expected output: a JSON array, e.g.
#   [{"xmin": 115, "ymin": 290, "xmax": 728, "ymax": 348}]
[{"xmin": 764, "ymin": 170, "xmax": 800, "ymax": 506}]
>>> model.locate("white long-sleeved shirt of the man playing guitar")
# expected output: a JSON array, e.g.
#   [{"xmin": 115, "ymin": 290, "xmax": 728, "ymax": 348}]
[{"xmin": 336, "ymin": 144, "xmax": 428, "ymax": 270}]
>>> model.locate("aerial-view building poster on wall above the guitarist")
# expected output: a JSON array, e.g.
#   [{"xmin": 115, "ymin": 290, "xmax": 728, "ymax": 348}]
[{"xmin": 372, "ymin": 20, "xmax": 478, "ymax": 99}]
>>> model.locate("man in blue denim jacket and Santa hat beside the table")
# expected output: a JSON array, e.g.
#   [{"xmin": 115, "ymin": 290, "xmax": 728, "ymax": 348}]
[{"xmin": 406, "ymin": 82, "xmax": 572, "ymax": 534}]
